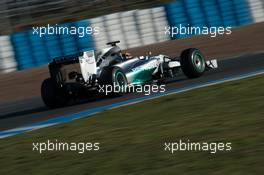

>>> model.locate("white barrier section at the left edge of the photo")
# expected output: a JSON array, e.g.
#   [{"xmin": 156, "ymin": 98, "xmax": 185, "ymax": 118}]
[{"xmin": 0, "ymin": 36, "xmax": 17, "ymax": 73}]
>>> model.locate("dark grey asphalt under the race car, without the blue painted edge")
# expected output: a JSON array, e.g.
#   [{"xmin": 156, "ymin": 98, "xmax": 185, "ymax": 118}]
[{"xmin": 0, "ymin": 54, "xmax": 264, "ymax": 131}]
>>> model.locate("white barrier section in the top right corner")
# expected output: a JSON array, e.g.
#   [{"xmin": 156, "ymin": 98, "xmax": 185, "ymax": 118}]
[{"xmin": 248, "ymin": 0, "xmax": 264, "ymax": 23}]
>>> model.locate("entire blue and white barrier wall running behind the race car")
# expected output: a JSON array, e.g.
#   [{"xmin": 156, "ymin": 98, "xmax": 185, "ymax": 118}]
[{"xmin": 0, "ymin": 0, "xmax": 264, "ymax": 71}]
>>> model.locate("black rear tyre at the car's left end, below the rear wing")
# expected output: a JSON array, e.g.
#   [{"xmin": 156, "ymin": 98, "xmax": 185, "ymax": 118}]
[{"xmin": 41, "ymin": 78, "xmax": 68, "ymax": 108}]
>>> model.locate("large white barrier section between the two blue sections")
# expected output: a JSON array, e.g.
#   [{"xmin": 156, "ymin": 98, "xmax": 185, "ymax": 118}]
[{"xmin": 90, "ymin": 7, "xmax": 170, "ymax": 49}]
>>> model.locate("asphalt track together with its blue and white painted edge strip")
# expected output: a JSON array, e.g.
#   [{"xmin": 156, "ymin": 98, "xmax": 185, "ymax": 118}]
[{"xmin": 0, "ymin": 54, "xmax": 264, "ymax": 138}]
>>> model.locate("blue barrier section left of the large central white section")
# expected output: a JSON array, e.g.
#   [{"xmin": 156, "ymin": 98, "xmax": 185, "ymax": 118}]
[{"xmin": 11, "ymin": 21, "xmax": 93, "ymax": 70}]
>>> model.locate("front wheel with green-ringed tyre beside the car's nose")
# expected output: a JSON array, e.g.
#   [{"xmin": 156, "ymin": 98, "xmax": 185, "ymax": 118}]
[{"xmin": 180, "ymin": 48, "xmax": 206, "ymax": 78}]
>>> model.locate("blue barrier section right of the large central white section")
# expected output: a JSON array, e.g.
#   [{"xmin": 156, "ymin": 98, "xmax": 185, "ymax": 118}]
[{"xmin": 165, "ymin": 0, "xmax": 253, "ymax": 39}]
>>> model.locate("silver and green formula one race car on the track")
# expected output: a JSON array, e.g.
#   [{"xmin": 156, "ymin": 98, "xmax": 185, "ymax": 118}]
[{"xmin": 41, "ymin": 41, "xmax": 217, "ymax": 108}]
